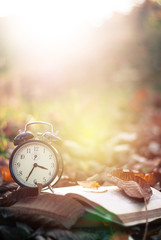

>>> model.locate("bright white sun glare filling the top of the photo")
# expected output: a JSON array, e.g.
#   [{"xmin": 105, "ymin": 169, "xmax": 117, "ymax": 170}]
[{"xmin": 0, "ymin": 0, "xmax": 143, "ymax": 72}]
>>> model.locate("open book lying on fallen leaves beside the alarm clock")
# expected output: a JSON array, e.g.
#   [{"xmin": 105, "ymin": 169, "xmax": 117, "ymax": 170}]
[{"xmin": 50, "ymin": 186, "xmax": 161, "ymax": 226}]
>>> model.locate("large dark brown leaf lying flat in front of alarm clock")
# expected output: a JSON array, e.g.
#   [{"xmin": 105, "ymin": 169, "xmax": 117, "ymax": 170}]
[{"xmin": 1, "ymin": 193, "xmax": 85, "ymax": 228}]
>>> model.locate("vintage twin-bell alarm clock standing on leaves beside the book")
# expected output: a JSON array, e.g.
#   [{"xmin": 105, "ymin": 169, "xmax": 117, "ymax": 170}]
[{"xmin": 9, "ymin": 121, "xmax": 63, "ymax": 192}]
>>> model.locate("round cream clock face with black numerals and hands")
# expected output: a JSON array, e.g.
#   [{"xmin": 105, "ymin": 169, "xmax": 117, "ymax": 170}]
[{"xmin": 9, "ymin": 140, "xmax": 58, "ymax": 188}]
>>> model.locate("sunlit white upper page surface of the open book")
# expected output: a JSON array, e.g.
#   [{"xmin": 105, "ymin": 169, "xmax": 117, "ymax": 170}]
[{"xmin": 51, "ymin": 186, "xmax": 161, "ymax": 216}]
